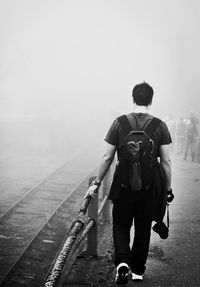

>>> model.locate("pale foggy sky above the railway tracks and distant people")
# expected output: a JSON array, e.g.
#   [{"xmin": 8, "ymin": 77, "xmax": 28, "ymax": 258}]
[{"xmin": 0, "ymin": 0, "xmax": 200, "ymax": 164}]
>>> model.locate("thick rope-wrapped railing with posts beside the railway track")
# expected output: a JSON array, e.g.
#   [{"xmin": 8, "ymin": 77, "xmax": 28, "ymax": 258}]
[{"xmin": 44, "ymin": 173, "xmax": 109, "ymax": 287}]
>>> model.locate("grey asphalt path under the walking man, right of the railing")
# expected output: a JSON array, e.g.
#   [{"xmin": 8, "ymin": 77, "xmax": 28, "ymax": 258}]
[{"xmin": 64, "ymin": 156, "xmax": 200, "ymax": 287}]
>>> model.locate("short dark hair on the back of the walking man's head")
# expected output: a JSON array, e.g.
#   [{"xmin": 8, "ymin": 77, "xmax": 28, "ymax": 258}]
[{"xmin": 132, "ymin": 82, "xmax": 153, "ymax": 106}]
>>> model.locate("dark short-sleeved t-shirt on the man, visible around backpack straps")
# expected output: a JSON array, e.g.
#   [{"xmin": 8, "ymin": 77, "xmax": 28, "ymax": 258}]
[{"xmin": 105, "ymin": 113, "xmax": 172, "ymax": 156}]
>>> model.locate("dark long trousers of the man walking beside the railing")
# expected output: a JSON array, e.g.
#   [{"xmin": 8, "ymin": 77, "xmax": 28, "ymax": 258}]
[{"xmin": 113, "ymin": 190, "xmax": 152, "ymax": 275}]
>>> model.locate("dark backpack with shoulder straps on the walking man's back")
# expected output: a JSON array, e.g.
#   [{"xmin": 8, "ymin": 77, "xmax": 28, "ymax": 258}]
[{"xmin": 117, "ymin": 115, "xmax": 161, "ymax": 192}]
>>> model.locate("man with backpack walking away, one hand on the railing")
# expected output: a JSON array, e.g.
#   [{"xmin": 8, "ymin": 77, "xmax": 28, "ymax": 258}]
[{"xmin": 86, "ymin": 82, "xmax": 172, "ymax": 285}]
